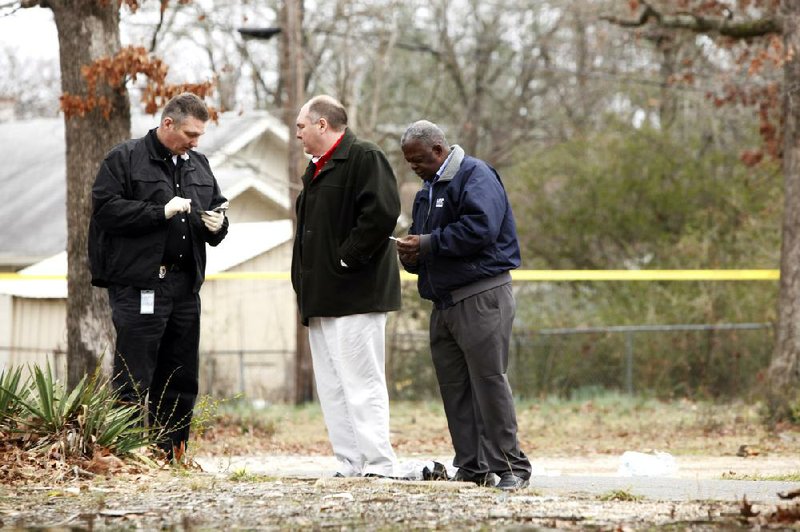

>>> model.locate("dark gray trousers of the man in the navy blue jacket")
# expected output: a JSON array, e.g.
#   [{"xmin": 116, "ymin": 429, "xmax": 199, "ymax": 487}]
[{"xmin": 430, "ymin": 284, "xmax": 531, "ymax": 479}]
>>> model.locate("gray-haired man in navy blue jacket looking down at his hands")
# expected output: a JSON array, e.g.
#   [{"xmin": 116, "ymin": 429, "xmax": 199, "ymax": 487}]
[{"xmin": 397, "ymin": 120, "xmax": 531, "ymax": 490}]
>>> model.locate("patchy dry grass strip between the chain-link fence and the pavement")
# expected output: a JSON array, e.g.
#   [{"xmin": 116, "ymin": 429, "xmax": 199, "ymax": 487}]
[{"xmin": 198, "ymin": 393, "xmax": 800, "ymax": 457}]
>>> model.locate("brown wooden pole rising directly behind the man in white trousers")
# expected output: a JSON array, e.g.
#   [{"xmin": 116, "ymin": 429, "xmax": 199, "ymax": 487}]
[{"xmin": 281, "ymin": 0, "xmax": 314, "ymax": 404}]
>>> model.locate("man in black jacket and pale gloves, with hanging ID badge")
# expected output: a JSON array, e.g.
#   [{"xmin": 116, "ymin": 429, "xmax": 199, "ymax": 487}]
[{"xmin": 89, "ymin": 93, "xmax": 228, "ymax": 460}]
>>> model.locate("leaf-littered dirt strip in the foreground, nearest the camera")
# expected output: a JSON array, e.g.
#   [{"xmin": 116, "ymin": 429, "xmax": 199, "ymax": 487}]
[{"xmin": 0, "ymin": 472, "xmax": 754, "ymax": 530}]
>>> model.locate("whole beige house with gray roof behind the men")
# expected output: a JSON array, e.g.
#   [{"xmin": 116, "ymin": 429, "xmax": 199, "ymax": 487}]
[{"xmin": 0, "ymin": 112, "xmax": 296, "ymax": 400}]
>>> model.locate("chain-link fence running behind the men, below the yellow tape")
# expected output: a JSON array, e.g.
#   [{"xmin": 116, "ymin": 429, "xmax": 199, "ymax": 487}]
[{"xmin": 0, "ymin": 323, "xmax": 773, "ymax": 400}]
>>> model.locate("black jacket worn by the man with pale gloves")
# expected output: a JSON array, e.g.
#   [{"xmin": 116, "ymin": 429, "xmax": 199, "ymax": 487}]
[{"xmin": 89, "ymin": 130, "xmax": 228, "ymax": 292}]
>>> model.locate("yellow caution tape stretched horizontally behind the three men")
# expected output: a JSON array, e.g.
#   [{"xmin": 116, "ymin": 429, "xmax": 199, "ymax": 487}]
[{"xmin": 0, "ymin": 270, "xmax": 780, "ymax": 282}]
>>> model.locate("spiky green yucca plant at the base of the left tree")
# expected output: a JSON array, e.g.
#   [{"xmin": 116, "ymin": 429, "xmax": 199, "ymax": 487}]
[{"xmin": 0, "ymin": 365, "xmax": 153, "ymax": 458}]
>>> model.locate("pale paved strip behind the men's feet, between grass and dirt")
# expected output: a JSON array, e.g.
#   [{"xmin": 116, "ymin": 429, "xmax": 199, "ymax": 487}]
[{"xmin": 195, "ymin": 455, "xmax": 800, "ymax": 504}]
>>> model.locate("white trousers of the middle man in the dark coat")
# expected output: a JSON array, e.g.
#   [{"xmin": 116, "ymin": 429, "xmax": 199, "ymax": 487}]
[{"xmin": 308, "ymin": 312, "xmax": 397, "ymax": 476}]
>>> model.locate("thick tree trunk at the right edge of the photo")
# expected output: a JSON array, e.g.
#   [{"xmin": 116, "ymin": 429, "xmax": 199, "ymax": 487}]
[{"xmin": 769, "ymin": 0, "xmax": 800, "ymax": 418}]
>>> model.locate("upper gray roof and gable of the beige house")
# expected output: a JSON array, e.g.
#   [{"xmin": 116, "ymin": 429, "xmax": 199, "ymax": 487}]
[{"xmin": 0, "ymin": 111, "xmax": 290, "ymax": 271}]
